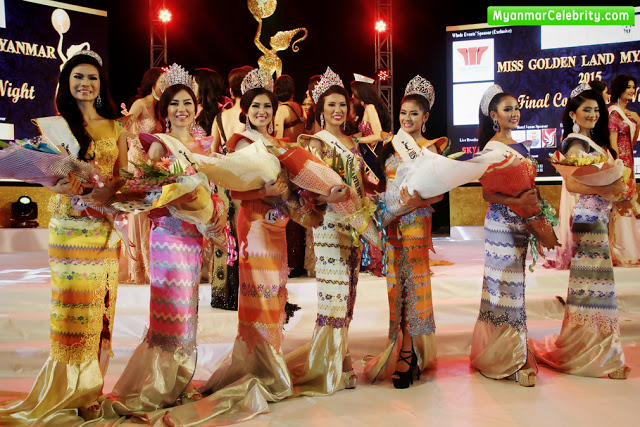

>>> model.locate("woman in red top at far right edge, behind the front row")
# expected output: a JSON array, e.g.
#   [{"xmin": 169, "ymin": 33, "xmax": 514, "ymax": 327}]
[{"xmin": 609, "ymin": 74, "xmax": 640, "ymax": 267}]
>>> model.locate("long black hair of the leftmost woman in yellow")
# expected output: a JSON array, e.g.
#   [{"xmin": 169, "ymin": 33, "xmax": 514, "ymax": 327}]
[{"xmin": 56, "ymin": 54, "xmax": 116, "ymax": 160}]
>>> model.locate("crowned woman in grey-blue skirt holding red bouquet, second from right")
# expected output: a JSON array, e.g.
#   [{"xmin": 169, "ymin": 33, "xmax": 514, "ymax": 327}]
[{"xmin": 470, "ymin": 85, "xmax": 539, "ymax": 387}]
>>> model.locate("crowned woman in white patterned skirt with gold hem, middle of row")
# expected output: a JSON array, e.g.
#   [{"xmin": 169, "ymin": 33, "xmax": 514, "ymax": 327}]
[{"xmin": 287, "ymin": 68, "xmax": 365, "ymax": 396}]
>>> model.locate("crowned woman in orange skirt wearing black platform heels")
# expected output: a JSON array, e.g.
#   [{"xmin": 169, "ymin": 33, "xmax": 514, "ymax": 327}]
[{"xmin": 365, "ymin": 76, "xmax": 442, "ymax": 388}]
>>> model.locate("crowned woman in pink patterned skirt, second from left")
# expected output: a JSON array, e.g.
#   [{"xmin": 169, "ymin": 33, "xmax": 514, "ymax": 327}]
[{"xmin": 103, "ymin": 64, "xmax": 225, "ymax": 418}]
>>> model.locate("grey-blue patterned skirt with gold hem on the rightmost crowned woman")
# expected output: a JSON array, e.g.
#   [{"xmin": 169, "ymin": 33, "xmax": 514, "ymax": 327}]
[{"xmin": 532, "ymin": 195, "xmax": 624, "ymax": 377}]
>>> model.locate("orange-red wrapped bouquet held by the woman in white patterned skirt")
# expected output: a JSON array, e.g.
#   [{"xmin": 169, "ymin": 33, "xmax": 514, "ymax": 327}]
[{"xmin": 278, "ymin": 147, "xmax": 380, "ymax": 247}]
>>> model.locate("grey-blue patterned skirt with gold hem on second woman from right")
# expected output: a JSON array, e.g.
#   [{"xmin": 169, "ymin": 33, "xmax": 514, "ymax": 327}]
[{"xmin": 470, "ymin": 203, "xmax": 528, "ymax": 379}]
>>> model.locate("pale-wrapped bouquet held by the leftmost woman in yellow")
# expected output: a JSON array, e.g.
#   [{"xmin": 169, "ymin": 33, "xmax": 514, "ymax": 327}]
[{"xmin": 0, "ymin": 136, "xmax": 103, "ymax": 186}]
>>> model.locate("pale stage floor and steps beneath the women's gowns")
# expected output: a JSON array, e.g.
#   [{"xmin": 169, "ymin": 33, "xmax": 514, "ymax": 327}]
[{"xmin": 0, "ymin": 238, "xmax": 640, "ymax": 427}]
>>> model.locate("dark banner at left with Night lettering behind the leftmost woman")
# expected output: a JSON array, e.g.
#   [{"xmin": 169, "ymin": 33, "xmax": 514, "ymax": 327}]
[{"xmin": 0, "ymin": 0, "xmax": 108, "ymax": 140}]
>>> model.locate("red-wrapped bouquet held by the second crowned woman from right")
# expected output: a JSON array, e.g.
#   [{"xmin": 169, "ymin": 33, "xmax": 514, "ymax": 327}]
[{"xmin": 480, "ymin": 154, "xmax": 558, "ymax": 258}]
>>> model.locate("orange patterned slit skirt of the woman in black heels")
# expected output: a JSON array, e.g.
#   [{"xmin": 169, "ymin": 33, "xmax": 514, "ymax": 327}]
[{"xmin": 364, "ymin": 210, "xmax": 436, "ymax": 382}]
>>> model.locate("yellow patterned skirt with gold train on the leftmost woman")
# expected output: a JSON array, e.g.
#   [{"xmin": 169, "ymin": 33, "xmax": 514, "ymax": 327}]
[{"xmin": 0, "ymin": 216, "xmax": 118, "ymax": 425}]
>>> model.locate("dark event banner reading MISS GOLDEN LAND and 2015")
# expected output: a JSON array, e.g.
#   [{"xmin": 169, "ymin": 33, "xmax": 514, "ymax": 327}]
[{"xmin": 447, "ymin": 11, "xmax": 640, "ymax": 181}]
